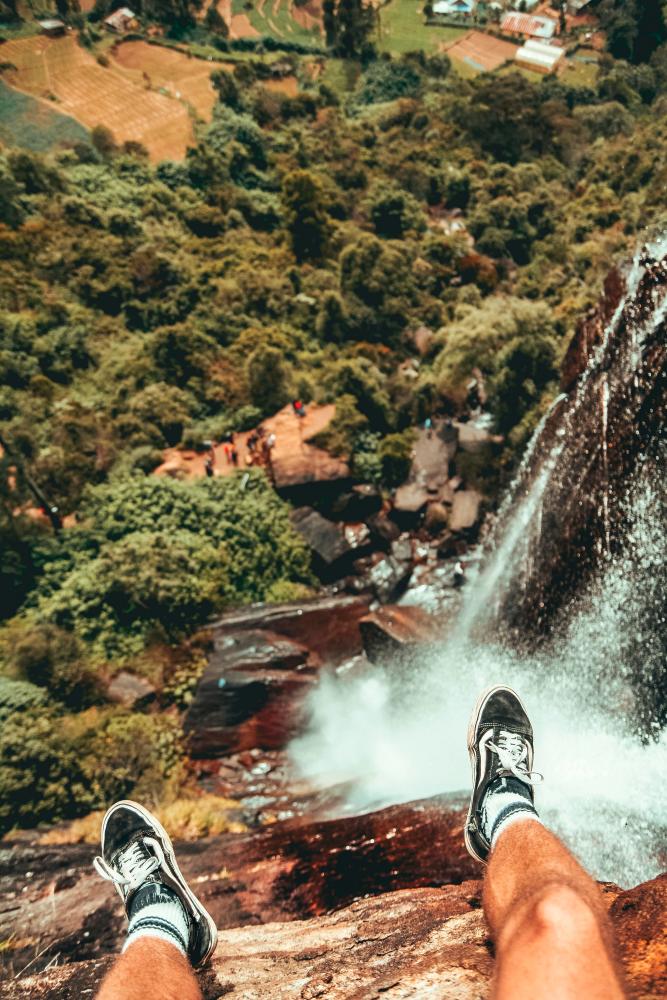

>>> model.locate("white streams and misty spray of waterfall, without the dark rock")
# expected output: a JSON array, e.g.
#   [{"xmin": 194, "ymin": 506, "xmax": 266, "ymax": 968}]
[{"xmin": 291, "ymin": 244, "xmax": 667, "ymax": 886}]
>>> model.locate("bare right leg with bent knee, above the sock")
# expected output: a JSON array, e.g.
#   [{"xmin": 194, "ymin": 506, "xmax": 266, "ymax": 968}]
[{"xmin": 484, "ymin": 819, "xmax": 626, "ymax": 1000}]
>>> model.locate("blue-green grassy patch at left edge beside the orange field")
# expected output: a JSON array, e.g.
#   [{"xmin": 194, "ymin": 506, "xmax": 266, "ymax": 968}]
[{"xmin": 0, "ymin": 80, "xmax": 88, "ymax": 153}]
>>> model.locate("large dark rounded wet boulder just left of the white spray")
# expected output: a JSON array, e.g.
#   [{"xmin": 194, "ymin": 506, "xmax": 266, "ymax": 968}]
[{"xmin": 184, "ymin": 631, "xmax": 319, "ymax": 758}]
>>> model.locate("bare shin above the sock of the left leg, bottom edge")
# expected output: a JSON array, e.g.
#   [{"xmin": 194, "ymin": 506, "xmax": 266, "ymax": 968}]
[{"xmin": 97, "ymin": 937, "xmax": 202, "ymax": 1000}]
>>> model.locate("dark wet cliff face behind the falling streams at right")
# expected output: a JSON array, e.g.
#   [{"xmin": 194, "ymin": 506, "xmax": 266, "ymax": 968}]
[{"xmin": 486, "ymin": 242, "xmax": 667, "ymax": 720}]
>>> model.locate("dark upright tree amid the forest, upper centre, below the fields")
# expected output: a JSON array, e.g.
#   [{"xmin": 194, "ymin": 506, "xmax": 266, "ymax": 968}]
[{"xmin": 283, "ymin": 170, "xmax": 331, "ymax": 263}]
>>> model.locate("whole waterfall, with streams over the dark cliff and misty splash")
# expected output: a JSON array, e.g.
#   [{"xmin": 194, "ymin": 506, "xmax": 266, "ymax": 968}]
[{"xmin": 291, "ymin": 240, "xmax": 667, "ymax": 886}]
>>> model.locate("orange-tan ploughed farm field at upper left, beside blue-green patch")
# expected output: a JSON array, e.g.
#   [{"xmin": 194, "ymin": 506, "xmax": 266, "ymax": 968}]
[{"xmin": 3, "ymin": 35, "xmax": 228, "ymax": 162}]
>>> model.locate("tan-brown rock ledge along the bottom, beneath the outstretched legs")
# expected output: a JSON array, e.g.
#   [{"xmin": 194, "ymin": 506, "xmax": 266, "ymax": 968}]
[{"xmin": 0, "ymin": 876, "xmax": 667, "ymax": 1000}]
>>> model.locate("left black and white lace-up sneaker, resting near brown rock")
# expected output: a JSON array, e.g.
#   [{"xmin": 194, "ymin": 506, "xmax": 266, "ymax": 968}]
[{"xmin": 93, "ymin": 800, "xmax": 218, "ymax": 968}]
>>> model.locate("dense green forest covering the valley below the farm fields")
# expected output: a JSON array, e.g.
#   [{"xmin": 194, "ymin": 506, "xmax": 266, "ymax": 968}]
[{"xmin": 0, "ymin": 0, "xmax": 667, "ymax": 832}]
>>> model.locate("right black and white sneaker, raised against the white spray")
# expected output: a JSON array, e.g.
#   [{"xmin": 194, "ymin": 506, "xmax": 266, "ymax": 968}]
[{"xmin": 464, "ymin": 685, "xmax": 542, "ymax": 864}]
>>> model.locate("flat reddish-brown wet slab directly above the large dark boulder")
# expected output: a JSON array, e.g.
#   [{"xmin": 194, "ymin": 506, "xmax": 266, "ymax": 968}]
[{"xmin": 211, "ymin": 595, "xmax": 370, "ymax": 665}]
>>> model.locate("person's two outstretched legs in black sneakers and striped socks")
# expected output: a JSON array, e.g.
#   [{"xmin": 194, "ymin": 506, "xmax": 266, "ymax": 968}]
[{"xmin": 94, "ymin": 685, "xmax": 628, "ymax": 1000}]
